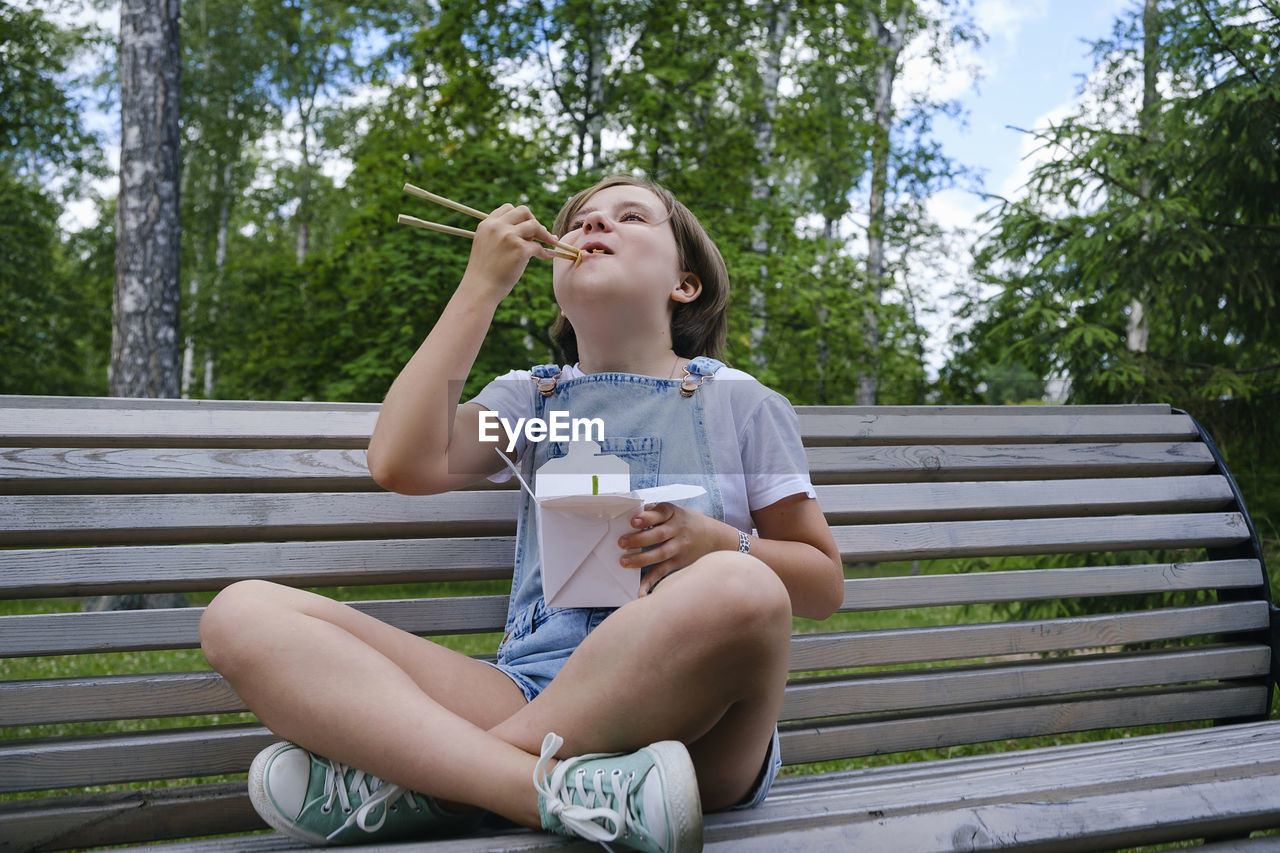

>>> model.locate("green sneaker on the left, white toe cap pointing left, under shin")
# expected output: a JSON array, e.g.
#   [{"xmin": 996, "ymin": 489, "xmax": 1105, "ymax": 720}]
[{"xmin": 248, "ymin": 742, "xmax": 480, "ymax": 847}]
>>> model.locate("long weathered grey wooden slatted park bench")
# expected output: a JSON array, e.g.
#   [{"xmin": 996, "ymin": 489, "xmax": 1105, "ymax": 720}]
[{"xmin": 0, "ymin": 397, "xmax": 1280, "ymax": 850}]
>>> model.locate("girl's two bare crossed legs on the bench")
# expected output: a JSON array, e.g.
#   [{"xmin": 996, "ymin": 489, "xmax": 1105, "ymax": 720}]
[{"xmin": 200, "ymin": 552, "xmax": 791, "ymax": 827}]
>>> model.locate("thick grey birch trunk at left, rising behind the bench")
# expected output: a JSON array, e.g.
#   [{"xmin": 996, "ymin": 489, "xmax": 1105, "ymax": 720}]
[{"xmin": 108, "ymin": 0, "xmax": 182, "ymax": 397}]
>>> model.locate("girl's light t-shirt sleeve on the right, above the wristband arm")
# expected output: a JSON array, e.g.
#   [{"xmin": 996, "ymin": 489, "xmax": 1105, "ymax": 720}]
[{"xmin": 739, "ymin": 392, "xmax": 817, "ymax": 512}]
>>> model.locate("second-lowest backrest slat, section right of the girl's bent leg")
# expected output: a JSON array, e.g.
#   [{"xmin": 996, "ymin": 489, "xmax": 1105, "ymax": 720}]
[{"xmin": 778, "ymin": 646, "xmax": 1271, "ymax": 721}]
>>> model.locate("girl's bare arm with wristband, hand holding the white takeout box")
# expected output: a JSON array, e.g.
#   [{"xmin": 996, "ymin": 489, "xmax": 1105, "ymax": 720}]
[{"xmin": 618, "ymin": 494, "xmax": 845, "ymax": 619}]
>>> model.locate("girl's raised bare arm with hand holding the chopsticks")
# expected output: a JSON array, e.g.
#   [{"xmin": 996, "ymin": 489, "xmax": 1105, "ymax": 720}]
[{"xmin": 369, "ymin": 205, "xmax": 554, "ymax": 494}]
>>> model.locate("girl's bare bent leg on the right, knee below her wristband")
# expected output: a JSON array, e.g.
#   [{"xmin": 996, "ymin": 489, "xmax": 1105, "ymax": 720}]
[{"xmin": 493, "ymin": 552, "xmax": 791, "ymax": 811}]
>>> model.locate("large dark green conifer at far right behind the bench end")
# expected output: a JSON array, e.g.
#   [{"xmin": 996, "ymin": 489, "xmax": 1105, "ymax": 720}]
[{"xmin": 948, "ymin": 0, "xmax": 1280, "ymax": 525}]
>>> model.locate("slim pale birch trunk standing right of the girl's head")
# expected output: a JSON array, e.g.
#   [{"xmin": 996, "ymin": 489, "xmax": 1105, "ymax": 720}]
[{"xmin": 854, "ymin": 3, "xmax": 908, "ymax": 406}]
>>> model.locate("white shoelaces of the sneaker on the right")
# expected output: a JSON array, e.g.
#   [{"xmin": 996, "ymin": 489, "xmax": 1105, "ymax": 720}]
[{"xmin": 534, "ymin": 733, "xmax": 641, "ymax": 850}]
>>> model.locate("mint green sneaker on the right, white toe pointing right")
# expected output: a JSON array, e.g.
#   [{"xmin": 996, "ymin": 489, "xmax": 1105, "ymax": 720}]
[{"xmin": 534, "ymin": 733, "xmax": 703, "ymax": 853}]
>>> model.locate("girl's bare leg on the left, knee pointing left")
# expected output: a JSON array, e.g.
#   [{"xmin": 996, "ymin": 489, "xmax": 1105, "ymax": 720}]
[{"xmin": 200, "ymin": 581, "xmax": 540, "ymax": 827}]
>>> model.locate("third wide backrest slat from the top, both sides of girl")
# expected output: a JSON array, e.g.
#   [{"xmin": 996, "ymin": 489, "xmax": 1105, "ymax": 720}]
[{"xmin": 0, "ymin": 476, "xmax": 1233, "ymax": 547}]
